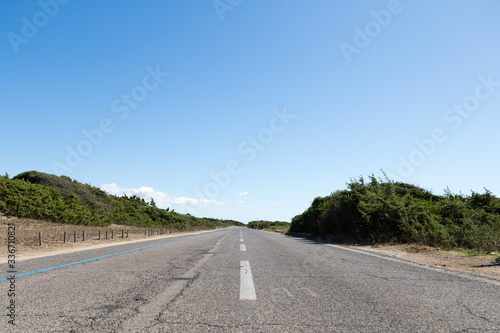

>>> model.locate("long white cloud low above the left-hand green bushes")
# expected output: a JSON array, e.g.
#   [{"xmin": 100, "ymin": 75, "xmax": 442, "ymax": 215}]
[{"xmin": 97, "ymin": 183, "xmax": 225, "ymax": 208}]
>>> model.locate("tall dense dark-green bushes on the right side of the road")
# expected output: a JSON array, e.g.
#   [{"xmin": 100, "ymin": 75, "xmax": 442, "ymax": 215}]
[{"xmin": 290, "ymin": 175, "xmax": 500, "ymax": 251}]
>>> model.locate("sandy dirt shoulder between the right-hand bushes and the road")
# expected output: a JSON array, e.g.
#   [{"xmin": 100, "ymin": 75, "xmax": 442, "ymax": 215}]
[{"xmin": 360, "ymin": 244, "xmax": 500, "ymax": 280}]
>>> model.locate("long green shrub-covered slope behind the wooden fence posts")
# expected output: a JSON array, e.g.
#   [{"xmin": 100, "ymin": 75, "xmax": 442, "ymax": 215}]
[{"xmin": 0, "ymin": 171, "xmax": 244, "ymax": 230}]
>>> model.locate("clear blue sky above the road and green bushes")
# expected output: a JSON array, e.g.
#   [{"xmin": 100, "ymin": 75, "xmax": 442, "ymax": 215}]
[{"xmin": 0, "ymin": 0, "xmax": 500, "ymax": 222}]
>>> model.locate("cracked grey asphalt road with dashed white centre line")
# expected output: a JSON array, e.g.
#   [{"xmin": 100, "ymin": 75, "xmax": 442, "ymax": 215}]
[{"xmin": 0, "ymin": 228, "xmax": 500, "ymax": 332}]
